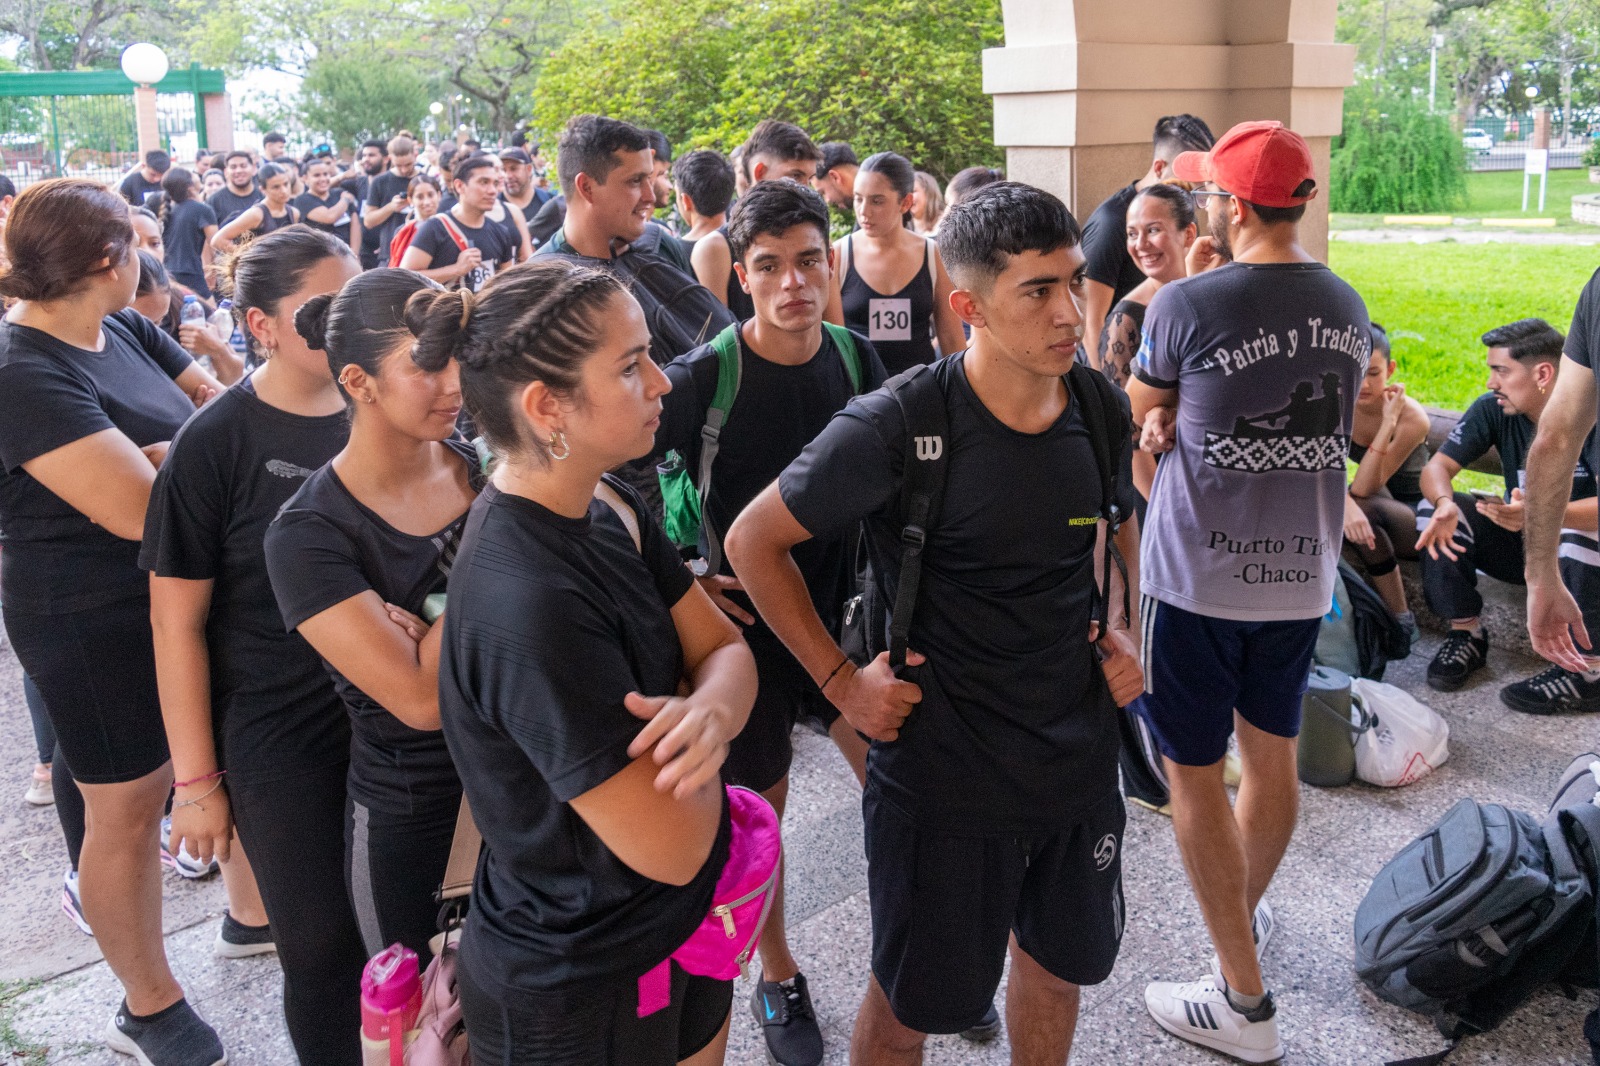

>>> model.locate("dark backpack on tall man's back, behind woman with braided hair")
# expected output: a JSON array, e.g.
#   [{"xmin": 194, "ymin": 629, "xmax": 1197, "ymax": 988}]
[{"xmin": 538, "ymin": 226, "xmax": 734, "ymax": 365}]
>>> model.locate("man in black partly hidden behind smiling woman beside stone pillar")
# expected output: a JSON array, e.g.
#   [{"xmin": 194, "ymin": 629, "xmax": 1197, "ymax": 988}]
[{"xmin": 1083, "ymin": 115, "xmax": 1213, "ymax": 365}]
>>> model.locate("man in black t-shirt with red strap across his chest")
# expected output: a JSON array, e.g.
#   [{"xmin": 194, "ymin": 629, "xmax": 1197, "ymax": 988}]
[{"xmin": 400, "ymin": 155, "xmax": 515, "ymax": 293}]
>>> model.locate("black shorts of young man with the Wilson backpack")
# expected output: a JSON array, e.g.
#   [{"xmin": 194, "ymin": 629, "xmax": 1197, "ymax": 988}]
[{"xmin": 862, "ymin": 784, "xmax": 1125, "ymax": 1032}]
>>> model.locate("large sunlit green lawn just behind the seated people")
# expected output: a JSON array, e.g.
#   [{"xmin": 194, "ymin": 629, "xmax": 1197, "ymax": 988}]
[{"xmin": 1328, "ymin": 240, "xmax": 1600, "ymax": 411}]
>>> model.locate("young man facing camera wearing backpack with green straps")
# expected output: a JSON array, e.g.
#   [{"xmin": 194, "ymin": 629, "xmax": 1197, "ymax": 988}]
[{"xmin": 656, "ymin": 180, "xmax": 883, "ymax": 1066}]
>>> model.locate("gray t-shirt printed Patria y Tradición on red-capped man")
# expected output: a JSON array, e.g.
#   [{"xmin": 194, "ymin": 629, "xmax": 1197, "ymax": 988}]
[{"xmin": 1134, "ymin": 262, "xmax": 1373, "ymax": 621}]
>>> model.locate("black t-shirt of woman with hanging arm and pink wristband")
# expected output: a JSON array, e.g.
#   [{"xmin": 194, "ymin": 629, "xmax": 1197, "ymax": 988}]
[{"xmin": 139, "ymin": 378, "xmax": 350, "ymax": 781}]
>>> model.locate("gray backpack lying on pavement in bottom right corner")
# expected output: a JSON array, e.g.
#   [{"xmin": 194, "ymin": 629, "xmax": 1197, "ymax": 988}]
[{"xmin": 1355, "ymin": 799, "xmax": 1600, "ymax": 1066}]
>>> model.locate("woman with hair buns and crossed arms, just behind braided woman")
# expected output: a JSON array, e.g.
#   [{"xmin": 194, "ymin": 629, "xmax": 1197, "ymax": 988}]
[{"xmin": 267, "ymin": 269, "xmax": 483, "ymax": 959}]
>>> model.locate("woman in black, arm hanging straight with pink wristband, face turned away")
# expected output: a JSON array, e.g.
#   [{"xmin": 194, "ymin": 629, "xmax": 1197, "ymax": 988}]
[{"xmin": 139, "ymin": 226, "xmax": 366, "ymax": 1066}]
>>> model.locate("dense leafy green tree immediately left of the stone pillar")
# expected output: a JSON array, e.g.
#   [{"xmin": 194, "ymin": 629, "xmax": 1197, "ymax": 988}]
[{"xmin": 533, "ymin": 0, "xmax": 1003, "ymax": 178}]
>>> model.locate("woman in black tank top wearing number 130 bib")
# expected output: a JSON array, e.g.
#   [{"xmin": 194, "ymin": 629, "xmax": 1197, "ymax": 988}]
[{"xmin": 827, "ymin": 152, "xmax": 966, "ymax": 376}]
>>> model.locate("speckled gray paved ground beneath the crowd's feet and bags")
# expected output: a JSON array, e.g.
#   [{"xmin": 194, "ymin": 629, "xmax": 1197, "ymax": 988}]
[{"xmin": 0, "ymin": 624, "xmax": 1595, "ymax": 1066}]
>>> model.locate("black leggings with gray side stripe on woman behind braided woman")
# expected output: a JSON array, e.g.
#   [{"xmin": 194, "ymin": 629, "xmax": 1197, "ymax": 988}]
[{"xmin": 344, "ymin": 792, "xmax": 461, "ymax": 967}]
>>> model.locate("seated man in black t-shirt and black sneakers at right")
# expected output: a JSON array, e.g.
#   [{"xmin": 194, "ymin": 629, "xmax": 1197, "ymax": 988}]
[{"xmin": 1416, "ymin": 319, "xmax": 1600, "ymax": 714}]
